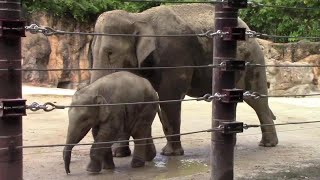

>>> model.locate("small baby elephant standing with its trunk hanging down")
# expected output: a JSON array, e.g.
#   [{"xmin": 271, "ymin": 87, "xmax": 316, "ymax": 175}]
[{"xmin": 63, "ymin": 72, "xmax": 159, "ymax": 174}]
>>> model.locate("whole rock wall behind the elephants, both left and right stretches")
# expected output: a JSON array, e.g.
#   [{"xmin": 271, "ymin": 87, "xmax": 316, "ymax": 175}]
[{"xmin": 22, "ymin": 14, "xmax": 320, "ymax": 95}]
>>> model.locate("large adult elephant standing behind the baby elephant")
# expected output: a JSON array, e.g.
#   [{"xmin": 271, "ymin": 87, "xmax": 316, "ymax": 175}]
[{"xmin": 91, "ymin": 4, "xmax": 278, "ymax": 156}]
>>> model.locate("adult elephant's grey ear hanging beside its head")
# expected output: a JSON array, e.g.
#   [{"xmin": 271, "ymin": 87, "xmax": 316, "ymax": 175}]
[{"xmin": 133, "ymin": 21, "xmax": 156, "ymax": 67}]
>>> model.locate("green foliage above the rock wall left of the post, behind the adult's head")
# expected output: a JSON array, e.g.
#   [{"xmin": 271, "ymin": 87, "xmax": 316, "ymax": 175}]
[{"xmin": 23, "ymin": 0, "xmax": 159, "ymax": 22}]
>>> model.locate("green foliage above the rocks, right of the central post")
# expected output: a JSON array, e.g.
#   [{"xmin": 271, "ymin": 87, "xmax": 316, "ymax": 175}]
[{"xmin": 240, "ymin": 0, "xmax": 320, "ymax": 42}]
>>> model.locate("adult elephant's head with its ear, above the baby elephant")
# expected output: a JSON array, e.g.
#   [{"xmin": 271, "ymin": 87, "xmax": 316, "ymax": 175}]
[{"xmin": 91, "ymin": 11, "xmax": 156, "ymax": 83}]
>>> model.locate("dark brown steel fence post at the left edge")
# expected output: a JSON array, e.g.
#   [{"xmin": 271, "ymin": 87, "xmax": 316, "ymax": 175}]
[{"xmin": 0, "ymin": 0, "xmax": 23, "ymax": 180}]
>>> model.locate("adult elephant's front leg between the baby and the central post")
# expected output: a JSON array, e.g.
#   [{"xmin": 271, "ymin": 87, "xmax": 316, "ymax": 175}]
[{"xmin": 160, "ymin": 103, "xmax": 184, "ymax": 156}]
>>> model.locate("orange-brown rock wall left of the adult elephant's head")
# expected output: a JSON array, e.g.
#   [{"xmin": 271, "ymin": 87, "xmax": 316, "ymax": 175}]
[{"xmin": 22, "ymin": 14, "xmax": 93, "ymax": 89}]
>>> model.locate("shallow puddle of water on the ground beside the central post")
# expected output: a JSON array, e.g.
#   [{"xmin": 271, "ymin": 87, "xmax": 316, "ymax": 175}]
[{"xmin": 153, "ymin": 156, "xmax": 209, "ymax": 180}]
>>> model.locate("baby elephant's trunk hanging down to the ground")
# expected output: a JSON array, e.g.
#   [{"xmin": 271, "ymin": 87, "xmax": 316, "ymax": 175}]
[{"xmin": 63, "ymin": 123, "xmax": 90, "ymax": 174}]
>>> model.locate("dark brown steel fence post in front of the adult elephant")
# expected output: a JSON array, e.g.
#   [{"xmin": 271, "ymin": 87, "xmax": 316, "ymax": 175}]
[{"xmin": 211, "ymin": 3, "xmax": 238, "ymax": 180}]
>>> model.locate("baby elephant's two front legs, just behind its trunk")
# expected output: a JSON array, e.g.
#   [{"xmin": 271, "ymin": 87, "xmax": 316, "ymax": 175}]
[{"xmin": 87, "ymin": 125, "xmax": 117, "ymax": 173}]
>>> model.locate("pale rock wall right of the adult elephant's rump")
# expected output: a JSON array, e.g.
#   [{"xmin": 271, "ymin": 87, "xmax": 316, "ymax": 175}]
[{"xmin": 259, "ymin": 39, "xmax": 320, "ymax": 95}]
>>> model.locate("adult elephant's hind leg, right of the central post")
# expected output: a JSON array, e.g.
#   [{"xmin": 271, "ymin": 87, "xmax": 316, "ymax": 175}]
[{"xmin": 245, "ymin": 98, "xmax": 278, "ymax": 147}]
